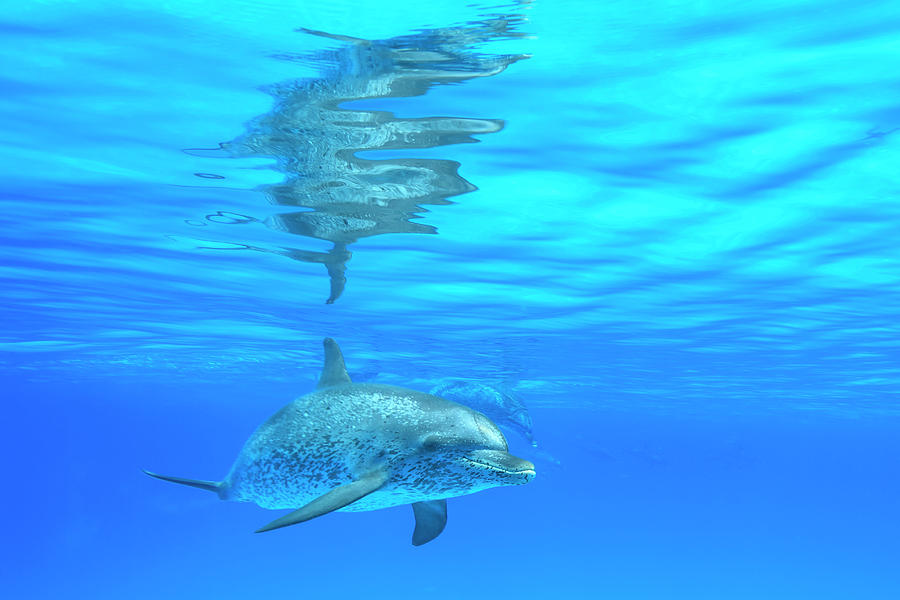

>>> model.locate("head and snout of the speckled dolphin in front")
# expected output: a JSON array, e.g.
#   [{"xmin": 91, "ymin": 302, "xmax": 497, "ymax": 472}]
[{"xmin": 420, "ymin": 406, "xmax": 535, "ymax": 495}]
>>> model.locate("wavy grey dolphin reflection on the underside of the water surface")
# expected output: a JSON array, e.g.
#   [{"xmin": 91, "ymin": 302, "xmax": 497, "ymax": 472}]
[{"xmin": 195, "ymin": 17, "xmax": 527, "ymax": 304}]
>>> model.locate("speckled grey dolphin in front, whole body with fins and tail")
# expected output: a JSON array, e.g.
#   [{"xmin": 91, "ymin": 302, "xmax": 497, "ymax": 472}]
[{"xmin": 145, "ymin": 338, "xmax": 535, "ymax": 546}]
